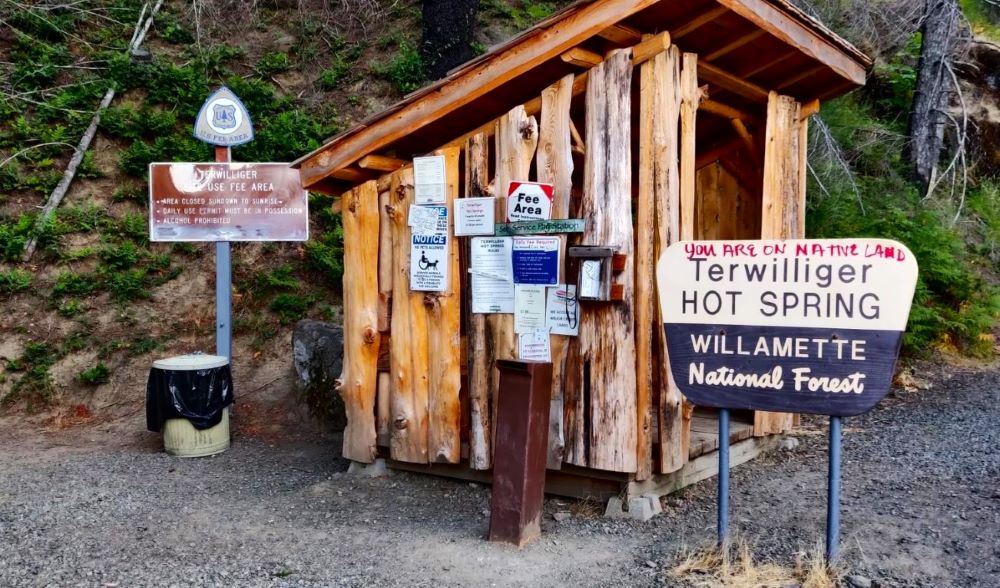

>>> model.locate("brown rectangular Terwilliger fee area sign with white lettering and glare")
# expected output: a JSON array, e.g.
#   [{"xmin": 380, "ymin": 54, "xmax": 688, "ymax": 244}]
[{"xmin": 149, "ymin": 163, "xmax": 309, "ymax": 241}]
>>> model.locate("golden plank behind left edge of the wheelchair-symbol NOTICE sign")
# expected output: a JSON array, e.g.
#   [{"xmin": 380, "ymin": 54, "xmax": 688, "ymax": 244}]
[{"xmin": 386, "ymin": 167, "xmax": 428, "ymax": 463}]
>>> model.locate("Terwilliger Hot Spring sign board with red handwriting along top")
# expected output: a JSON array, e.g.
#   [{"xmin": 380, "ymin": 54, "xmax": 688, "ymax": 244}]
[{"xmin": 657, "ymin": 239, "xmax": 917, "ymax": 416}]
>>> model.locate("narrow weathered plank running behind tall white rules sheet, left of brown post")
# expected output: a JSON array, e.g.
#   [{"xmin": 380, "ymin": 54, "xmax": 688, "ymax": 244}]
[{"xmin": 465, "ymin": 133, "xmax": 493, "ymax": 470}]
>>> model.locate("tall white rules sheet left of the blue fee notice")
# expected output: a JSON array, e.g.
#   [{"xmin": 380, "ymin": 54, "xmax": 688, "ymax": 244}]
[{"xmin": 469, "ymin": 237, "xmax": 514, "ymax": 314}]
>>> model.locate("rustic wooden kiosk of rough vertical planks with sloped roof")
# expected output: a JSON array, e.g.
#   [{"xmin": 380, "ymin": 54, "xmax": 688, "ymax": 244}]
[{"xmin": 295, "ymin": 0, "xmax": 871, "ymax": 498}]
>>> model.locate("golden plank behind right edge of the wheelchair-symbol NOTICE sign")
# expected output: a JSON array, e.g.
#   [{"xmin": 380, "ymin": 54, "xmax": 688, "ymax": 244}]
[{"xmin": 424, "ymin": 147, "xmax": 462, "ymax": 463}]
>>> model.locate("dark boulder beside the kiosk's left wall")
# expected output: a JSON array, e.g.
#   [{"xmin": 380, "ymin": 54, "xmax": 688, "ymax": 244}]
[{"xmin": 292, "ymin": 320, "xmax": 347, "ymax": 431}]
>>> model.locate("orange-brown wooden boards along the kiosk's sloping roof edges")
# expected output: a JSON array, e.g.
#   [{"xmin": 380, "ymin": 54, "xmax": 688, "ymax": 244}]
[{"xmin": 292, "ymin": 0, "xmax": 871, "ymax": 187}]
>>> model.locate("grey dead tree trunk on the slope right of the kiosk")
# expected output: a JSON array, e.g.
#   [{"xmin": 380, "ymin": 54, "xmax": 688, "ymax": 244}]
[{"xmin": 903, "ymin": 0, "xmax": 960, "ymax": 189}]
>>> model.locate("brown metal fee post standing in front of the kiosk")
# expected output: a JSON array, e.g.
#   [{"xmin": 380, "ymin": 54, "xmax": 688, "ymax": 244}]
[{"xmin": 489, "ymin": 359, "xmax": 552, "ymax": 547}]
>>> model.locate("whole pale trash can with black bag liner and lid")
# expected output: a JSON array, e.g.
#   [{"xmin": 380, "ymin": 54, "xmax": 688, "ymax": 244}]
[{"xmin": 146, "ymin": 353, "xmax": 233, "ymax": 457}]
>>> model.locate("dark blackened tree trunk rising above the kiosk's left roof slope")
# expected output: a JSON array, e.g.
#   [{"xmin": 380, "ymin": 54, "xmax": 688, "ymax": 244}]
[{"xmin": 420, "ymin": 0, "xmax": 479, "ymax": 80}]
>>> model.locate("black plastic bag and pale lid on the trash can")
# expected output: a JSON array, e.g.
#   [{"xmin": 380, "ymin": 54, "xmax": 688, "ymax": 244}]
[{"xmin": 146, "ymin": 354, "xmax": 233, "ymax": 432}]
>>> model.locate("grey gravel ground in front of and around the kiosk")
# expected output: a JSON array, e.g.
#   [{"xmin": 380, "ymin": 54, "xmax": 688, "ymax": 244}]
[{"xmin": 0, "ymin": 368, "xmax": 1000, "ymax": 587}]
